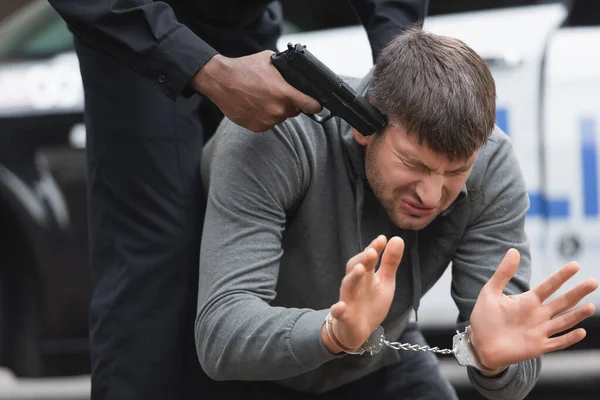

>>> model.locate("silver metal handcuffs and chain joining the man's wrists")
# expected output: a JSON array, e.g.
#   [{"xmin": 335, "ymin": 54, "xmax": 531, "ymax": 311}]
[{"xmin": 325, "ymin": 313, "xmax": 506, "ymax": 375}]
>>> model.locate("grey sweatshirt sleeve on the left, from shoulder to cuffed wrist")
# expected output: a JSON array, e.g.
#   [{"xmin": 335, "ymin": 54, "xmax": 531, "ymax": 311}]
[{"xmin": 195, "ymin": 120, "xmax": 337, "ymax": 380}]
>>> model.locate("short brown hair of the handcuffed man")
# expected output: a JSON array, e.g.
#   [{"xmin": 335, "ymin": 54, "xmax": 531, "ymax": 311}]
[{"xmin": 368, "ymin": 25, "xmax": 496, "ymax": 160}]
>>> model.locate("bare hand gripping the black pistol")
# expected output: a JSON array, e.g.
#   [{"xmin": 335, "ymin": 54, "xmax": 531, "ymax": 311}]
[{"xmin": 192, "ymin": 50, "xmax": 322, "ymax": 132}]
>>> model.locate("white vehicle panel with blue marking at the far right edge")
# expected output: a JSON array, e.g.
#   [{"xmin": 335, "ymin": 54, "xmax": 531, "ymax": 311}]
[{"xmin": 543, "ymin": 27, "xmax": 600, "ymax": 313}]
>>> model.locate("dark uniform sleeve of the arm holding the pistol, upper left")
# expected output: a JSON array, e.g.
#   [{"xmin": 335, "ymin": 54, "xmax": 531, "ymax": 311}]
[{"xmin": 49, "ymin": 0, "xmax": 217, "ymax": 99}]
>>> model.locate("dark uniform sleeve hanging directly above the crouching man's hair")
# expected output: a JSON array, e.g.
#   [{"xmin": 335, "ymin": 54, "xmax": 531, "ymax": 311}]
[{"xmin": 350, "ymin": 0, "xmax": 429, "ymax": 62}]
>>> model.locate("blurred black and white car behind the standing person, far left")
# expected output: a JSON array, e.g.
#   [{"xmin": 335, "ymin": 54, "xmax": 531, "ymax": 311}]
[{"xmin": 0, "ymin": 2, "xmax": 90, "ymax": 376}]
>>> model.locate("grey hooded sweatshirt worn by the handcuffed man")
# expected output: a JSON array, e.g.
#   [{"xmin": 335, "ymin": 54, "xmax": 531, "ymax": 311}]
[{"xmin": 195, "ymin": 77, "xmax": 540, "ymax": 400}]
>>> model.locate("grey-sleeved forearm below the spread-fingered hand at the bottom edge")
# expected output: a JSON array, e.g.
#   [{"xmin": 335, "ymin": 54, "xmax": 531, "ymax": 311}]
[{"xmin": 468, "ymin": 358, "xmax": 541, "ymax": 400}]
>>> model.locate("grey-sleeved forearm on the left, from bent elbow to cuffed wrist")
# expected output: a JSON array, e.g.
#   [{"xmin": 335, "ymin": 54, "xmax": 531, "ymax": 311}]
[{"xmin": 195, "ymin": 293, "xmax": 336, "ymax": 380}]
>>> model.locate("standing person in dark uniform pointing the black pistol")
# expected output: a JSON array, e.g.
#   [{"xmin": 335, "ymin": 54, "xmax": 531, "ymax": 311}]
[{"xmin": 49, "ymin": 0, "xmax": 427, "ymax": 400}]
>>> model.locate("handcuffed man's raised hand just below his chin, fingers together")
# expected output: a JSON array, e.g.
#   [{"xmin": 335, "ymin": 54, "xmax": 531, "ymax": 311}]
[{"xmin": 331, "ymin": 235, "xmax": 404, "ymax": 349}]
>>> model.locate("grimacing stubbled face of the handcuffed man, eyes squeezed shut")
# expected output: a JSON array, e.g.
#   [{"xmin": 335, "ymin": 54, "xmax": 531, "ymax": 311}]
[{"xmin": 354, "ymin": 124, "xmax": 477, "ymax": 230}]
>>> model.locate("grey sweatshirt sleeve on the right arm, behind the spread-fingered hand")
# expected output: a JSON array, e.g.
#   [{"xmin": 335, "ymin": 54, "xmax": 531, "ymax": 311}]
[{"xmin": 452, "ymin": 135, "xmax": 541, "ymax": 400}]
